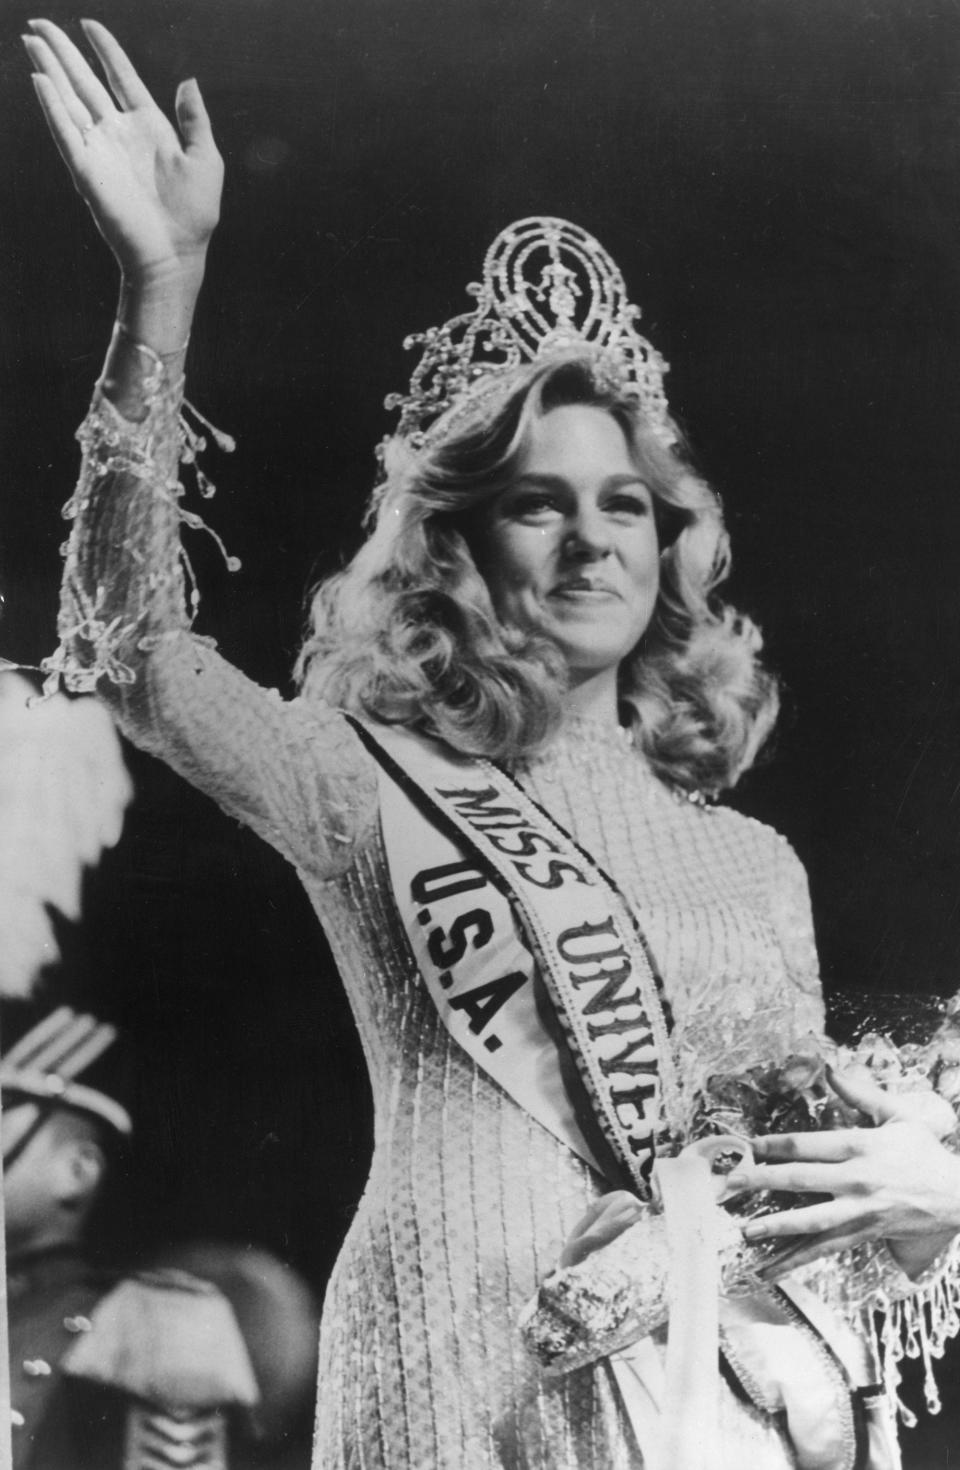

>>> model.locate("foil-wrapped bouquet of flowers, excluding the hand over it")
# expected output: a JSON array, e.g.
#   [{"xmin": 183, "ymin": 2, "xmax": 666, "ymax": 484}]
[{"xmin": 520, "ymin": 998, "xmax": 960, "ymax": 1381}]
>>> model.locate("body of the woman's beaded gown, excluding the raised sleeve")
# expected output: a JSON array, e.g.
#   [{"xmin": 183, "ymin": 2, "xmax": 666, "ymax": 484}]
[{"xmin": 305, "ymin": 717, "xmax": 822, "ymax": 1470}]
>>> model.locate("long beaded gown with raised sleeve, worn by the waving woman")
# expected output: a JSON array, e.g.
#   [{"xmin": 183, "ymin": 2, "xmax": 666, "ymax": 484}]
[{"xmin": 50, "ymin": 395, "xmax": 823, "ymax": 1470}]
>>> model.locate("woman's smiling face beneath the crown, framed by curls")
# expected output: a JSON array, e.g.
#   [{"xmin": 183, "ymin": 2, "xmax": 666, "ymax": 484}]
[{"xmin": 473, "ymin": 404, "xmax": 660, "ymax": 697}]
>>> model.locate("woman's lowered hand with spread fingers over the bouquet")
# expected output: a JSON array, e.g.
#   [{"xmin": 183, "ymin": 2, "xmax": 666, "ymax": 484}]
[{"xmin": 729, "ymin": 1076, "xmax": 960, "ymax": 1276}]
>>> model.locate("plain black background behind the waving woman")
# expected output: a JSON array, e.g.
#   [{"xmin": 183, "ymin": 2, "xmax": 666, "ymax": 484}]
[{"xmin": 0, "ymin": 0, "xmax": 960, "ymax": 1466}]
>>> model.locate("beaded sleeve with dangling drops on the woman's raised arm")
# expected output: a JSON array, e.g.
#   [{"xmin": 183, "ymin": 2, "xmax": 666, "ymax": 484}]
[{"xmin": 44, "ymin": 354, "xmax": 376, "ymax": 878}]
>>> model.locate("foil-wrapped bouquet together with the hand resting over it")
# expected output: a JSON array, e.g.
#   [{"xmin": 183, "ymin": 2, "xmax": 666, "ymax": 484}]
[{"xmin": 522, "ymin": 1004, "xmax": 960, "ymax": 1373}]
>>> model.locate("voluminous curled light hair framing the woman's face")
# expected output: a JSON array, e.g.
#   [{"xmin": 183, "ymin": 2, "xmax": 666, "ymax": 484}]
[{"xmin": 297, "ymin": 353, "xmax": 778, "ymax": 792}]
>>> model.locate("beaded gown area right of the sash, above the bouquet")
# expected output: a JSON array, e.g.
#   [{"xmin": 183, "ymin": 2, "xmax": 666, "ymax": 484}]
[{"xmin": 511, "ymin": 725, "xmax": 822, "ymax": 1072}]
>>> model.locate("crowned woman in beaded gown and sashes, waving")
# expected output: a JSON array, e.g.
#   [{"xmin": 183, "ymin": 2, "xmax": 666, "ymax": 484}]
[{"xmin": 26, "ymin": 22, "xmax": 960, "ymax": 1470}]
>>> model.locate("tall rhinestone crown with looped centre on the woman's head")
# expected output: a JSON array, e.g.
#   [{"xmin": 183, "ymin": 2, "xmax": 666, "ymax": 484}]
[{"xmin": 385, "ymin": 216, "xmax": 667, "ymax": 448}]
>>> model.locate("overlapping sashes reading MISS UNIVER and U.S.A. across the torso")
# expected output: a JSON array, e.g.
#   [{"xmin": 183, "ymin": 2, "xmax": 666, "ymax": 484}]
[{"xmin": 353, "ymin": 722, "xmax": 682, "ymax": 1194}]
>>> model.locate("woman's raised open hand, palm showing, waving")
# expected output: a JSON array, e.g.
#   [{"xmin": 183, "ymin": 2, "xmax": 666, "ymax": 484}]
[{"xmin": 24, "ymin": 21, "xmax": 223, "ymax": 281}]
